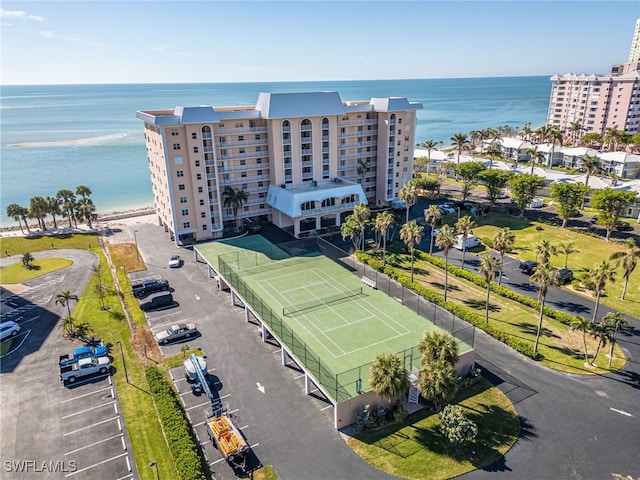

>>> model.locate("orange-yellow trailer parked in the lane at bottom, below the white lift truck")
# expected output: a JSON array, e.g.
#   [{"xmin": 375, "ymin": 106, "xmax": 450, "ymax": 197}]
[{"xmin": 204, "ymin": 404, "xmax": 249, "ymax": 470}]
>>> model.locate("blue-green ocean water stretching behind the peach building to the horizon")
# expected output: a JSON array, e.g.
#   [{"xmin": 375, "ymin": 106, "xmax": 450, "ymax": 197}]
[{"xmin": 0, "ymin": 76, "xmax": 551, "ymax": 227}]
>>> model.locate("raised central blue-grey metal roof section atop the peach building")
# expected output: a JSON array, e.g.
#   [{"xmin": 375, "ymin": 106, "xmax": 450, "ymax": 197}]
[{"xmin": 256, "ymin": 92, "xmax": 345, "ymax": 118}]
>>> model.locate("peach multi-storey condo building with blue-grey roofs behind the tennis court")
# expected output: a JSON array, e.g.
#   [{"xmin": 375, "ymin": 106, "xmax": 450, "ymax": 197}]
[{"xmin": 136, "ymin": 92, "xmax": 422, "ymax": 244}]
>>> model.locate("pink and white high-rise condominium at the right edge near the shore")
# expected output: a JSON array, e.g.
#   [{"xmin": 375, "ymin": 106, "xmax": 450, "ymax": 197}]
[{"xmin": 547, "ymin": 20, "xmax": 640, "ymax": 135}]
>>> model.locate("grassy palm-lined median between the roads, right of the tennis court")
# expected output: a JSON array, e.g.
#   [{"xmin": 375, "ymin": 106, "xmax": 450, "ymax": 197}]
[{"xmin": 357, "ymin": 247, "xmax": 626, "ymax": 374}]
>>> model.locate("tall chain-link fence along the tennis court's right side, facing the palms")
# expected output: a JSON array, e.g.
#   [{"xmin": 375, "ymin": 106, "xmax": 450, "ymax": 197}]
[{"xmin": 317, "ymin": 237, "xmax": 476, "ymax": 347}]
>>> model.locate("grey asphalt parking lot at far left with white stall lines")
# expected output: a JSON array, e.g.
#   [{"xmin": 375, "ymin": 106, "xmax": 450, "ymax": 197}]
[{"xmin": 0, "ymin": 251, "xmax": 137, "ymax": 480}]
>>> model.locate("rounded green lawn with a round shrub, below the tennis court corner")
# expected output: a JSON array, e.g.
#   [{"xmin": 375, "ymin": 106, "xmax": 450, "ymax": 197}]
[{"xmin": 347, "ymin": 380, "xmax": 520, "ymax": 480}]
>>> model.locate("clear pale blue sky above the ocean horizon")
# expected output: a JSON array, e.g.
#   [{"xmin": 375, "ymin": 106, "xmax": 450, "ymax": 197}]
[{"xmin": 0, "ymin": 0, "xmax": 640, "ymax": 85}]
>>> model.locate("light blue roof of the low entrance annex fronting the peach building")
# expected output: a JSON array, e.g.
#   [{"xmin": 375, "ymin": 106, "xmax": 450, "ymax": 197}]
[{"xmin": 267, "ymin": 180, "xmax": 367, "ymax": 218}]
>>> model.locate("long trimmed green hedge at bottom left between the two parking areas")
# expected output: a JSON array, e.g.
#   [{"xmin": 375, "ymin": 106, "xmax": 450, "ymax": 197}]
[{"xmin": 145, "ymin": 366, "xmax": 207, "ymax": 480}]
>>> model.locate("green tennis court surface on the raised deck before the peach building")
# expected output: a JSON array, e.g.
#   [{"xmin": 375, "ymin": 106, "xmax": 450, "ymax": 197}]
[{"xmin": 197, "ymin": 235, "xmax": 471, "ymax": 402}]
